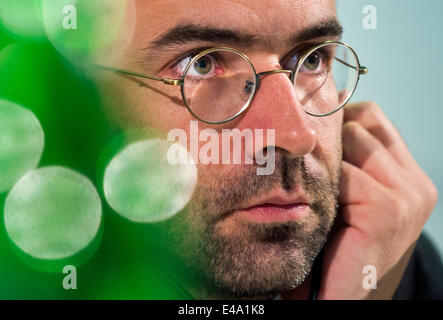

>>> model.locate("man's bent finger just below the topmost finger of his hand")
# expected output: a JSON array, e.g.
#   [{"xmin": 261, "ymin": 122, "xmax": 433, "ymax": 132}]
[{"xmin": 342, "ymin": 121, "xmax": 403, "ymax": 188}]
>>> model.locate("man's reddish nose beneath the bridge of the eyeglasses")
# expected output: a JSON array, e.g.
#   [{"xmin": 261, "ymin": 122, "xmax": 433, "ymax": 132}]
[{"xmin": 241, "ymin": 70, "xmax": 317, "ymax": 157}]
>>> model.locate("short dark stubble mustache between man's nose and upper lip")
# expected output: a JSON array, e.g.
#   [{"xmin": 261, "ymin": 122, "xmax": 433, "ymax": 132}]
[{"xmin": 196, "ymin": 152, "xmax": 338, "ymax": 223}]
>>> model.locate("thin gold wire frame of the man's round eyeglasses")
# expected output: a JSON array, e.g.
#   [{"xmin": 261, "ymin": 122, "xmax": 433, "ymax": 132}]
[{"xmin": 95, "ymin": 40, "xmax": 368, "ymax": 124}]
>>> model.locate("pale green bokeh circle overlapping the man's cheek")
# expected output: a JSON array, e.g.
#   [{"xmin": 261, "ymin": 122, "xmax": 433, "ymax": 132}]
[{"xmin": 103, "ymin": 139, "xmax": 197, "ymax": 222}]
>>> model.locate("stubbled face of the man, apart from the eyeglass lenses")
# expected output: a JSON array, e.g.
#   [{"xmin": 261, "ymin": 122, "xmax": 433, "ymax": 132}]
[{"xmin": 99, "ymin": 0, "xmax": 342, "ymax": 296}]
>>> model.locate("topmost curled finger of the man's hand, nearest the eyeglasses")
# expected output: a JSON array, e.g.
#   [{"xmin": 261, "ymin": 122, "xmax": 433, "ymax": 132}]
[{"xmin": 344, "ymin": 102, "xmax": 415, "ymax": 167}]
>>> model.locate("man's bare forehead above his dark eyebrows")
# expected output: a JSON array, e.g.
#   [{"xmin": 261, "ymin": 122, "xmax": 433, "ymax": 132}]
[{"xmin": 134, "ymin": 0, "xmax": 336, "ymax": 40}]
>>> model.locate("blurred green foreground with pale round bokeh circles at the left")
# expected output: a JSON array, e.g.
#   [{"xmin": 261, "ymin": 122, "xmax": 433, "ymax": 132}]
[{"xmin": 0, "ymin": 0, "xmax": 196, "ymax": 299}]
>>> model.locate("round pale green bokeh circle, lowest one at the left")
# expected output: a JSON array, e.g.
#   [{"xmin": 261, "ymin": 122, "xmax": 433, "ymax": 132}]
[{"xmin": 4, "ymin": 166, "xmax": 102, "ymax": 266}]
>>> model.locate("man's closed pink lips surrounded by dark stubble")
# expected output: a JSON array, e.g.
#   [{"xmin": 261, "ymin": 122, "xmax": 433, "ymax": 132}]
[{"xmin": 234, "ymin": 194, "xmax": 310, "ymax": 223}]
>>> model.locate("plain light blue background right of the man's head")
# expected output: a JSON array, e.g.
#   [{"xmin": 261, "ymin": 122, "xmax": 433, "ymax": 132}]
[{"xmin": 337, "ymin": 0, "xmax": 443, "ymax": 253}]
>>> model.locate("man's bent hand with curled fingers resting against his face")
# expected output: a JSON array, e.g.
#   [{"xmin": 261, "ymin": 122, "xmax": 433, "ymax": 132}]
[{"xmin": 319, "ymin": 102, "xmax": 438, "ymax": 299}]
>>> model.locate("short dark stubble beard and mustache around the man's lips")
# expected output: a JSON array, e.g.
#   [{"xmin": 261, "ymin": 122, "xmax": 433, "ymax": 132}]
[{"xmin": 162, "ymin": 157, "xmax": 340, "ymax": 299}]
